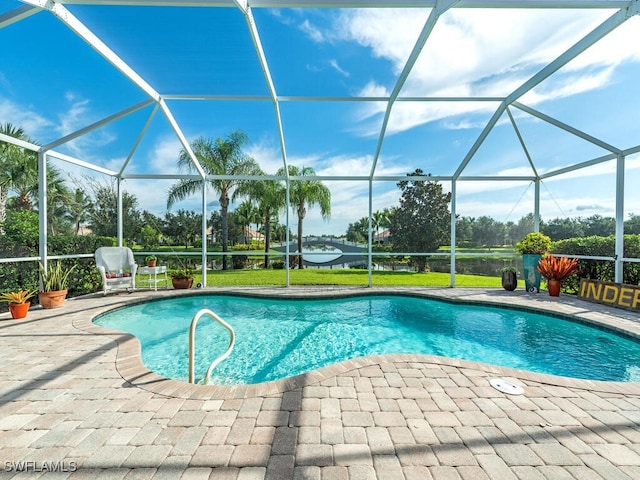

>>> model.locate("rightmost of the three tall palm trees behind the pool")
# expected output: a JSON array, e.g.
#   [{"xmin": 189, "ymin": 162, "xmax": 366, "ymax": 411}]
[{"xmin": 278, "ymin": 165, "xmax": 331, "ymax": 268}]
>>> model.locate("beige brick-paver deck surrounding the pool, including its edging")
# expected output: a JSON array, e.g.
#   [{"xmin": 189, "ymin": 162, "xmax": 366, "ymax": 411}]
[{"xmin": 0, "ymin": 287, "xmax": 640, "ymax": 480}]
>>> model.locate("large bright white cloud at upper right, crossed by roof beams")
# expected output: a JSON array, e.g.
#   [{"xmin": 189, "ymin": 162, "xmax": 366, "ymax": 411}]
[{"xmin": 325, "ymin": 9, "xmax": 640, "ymax": 135}]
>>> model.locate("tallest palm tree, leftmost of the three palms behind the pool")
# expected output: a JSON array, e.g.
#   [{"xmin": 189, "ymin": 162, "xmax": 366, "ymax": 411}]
[{"xmin": 167, "ymin": 130, "xmax": 260, "ymax": 270}]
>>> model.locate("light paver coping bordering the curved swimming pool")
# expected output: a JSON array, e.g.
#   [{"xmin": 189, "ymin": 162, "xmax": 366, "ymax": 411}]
[{"xmin": 72, "ymin": 287, "xmax": 640, "ymax": 399}]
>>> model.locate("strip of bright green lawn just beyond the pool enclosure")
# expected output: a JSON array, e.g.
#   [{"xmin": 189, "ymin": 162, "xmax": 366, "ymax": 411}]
[{"xmin": 196, "ymin": 268, "xmax": 524, "ymax": 287}]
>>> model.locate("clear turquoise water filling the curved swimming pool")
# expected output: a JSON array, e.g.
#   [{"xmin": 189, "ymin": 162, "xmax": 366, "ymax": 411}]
[{"xmin": 95, "ymin": 295, "xmax": 640, "ymax": 385}]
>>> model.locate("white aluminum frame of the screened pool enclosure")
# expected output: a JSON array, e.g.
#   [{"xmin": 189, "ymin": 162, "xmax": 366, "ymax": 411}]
[{"xmin": 10, "ymin": 0, "xmax": 640, "ymax": 286}]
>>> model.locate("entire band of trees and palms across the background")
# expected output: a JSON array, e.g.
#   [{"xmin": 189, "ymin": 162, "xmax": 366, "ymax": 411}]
[{"xmin": 0, "ymin": 123, "xmax": 640, "ymax": 271}]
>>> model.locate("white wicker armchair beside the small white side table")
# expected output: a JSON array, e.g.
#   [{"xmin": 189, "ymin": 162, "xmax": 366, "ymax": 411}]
[{"xmin": 95, "ymin": 247, "xmax": 138, "ymax": 295}]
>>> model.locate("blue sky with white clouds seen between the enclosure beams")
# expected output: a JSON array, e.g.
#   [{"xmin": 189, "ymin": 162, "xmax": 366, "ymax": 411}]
[{"xmin": 0, "ymin": 1, "xmax": 640, "ymax": 234}]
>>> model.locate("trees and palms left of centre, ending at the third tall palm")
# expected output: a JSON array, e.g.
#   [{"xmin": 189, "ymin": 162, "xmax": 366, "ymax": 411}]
[{"xmin": 0, "ymin": 123, "xmax": 331, "ymax": 270}]
